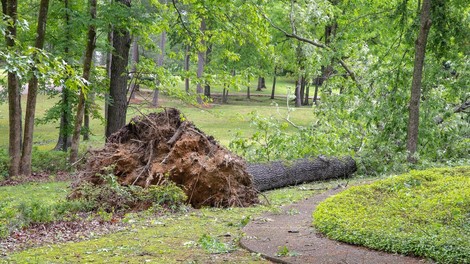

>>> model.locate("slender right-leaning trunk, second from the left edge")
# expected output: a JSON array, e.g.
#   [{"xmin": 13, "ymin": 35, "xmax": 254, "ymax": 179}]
[{"xmin": 20, "ymin": 0, "xmax": 49, "ymax": 176}]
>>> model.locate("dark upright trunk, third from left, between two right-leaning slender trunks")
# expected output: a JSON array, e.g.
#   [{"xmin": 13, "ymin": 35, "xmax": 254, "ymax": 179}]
[{"xmin": 54, "ymin": 0, "xmax": 72, "ymax": 151}]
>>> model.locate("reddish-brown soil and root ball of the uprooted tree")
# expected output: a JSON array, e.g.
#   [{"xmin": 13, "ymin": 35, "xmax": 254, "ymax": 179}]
[{"xmin": 71, "ymin": 108, "xmax": 258, "ymax": 208}]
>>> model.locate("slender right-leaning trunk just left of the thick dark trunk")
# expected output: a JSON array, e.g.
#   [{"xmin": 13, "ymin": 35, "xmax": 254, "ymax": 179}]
[{"xmin": 70, "ymin": 0, "xmax": 96, "ymax": 164}]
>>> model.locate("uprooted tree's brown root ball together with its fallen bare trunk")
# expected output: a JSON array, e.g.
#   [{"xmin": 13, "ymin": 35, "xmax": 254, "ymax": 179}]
[{"xmin": 70, "ymin": 108, "xmax": 356, "ymax": 208}]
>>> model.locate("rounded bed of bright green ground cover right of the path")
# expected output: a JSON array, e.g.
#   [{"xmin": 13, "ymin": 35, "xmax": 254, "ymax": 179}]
[{"xmin": 313, "ymin": 166, "xmax": 470, "ymax": 263}]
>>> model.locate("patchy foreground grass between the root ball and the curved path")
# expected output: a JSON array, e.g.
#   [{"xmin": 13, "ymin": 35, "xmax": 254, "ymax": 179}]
[{"xmin": 0, "ymin": 178, "xmax": 352, "ymax": 263}]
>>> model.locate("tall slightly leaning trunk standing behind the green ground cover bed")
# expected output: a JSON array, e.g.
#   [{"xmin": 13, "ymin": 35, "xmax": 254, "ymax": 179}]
[{"xmin": 406, "ymin": 0, "xmax": 431, "ymax": 163}]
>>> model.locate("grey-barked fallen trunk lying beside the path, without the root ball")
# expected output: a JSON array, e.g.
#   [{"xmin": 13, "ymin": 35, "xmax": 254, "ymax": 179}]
[{"xmin": 247, "ymin": 156, "xmax": 357, "ymax": 192}]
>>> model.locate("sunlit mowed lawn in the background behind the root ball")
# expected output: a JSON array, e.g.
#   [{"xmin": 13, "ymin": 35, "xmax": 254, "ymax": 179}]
[{"xmin": 0, "ymin": 81, "xmax": 314, "ymax": 150}]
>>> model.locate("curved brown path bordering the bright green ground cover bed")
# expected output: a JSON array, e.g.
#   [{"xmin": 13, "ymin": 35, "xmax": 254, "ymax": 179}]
[{"xmin": 240, "ymin": 188, "xmax": 427, "ymax": 264}]
